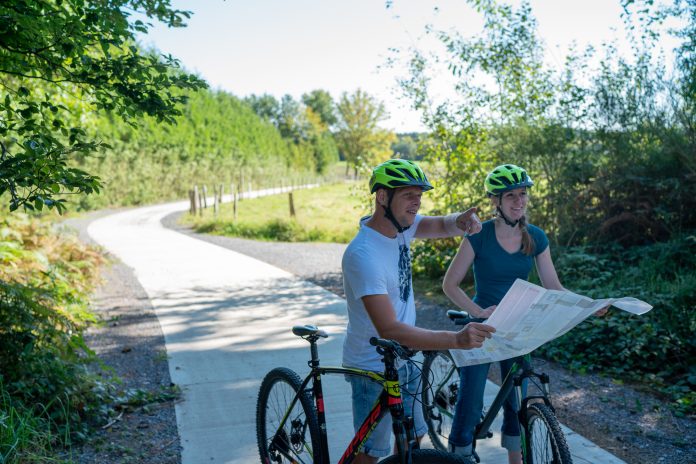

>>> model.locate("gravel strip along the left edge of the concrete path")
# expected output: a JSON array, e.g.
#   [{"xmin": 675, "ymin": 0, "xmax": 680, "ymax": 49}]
[{"xmin": 65, "ymin": 211, "xmax": 181, "ymax": 464}]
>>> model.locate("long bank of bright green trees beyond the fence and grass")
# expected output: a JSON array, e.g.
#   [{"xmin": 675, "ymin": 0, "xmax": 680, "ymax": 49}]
[{"xmin": 78, "ymin": 85, "xmax": 432, "ymax": 209}]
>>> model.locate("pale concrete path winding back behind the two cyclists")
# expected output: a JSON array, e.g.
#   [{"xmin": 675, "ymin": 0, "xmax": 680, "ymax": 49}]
[{"xmin": 88, "ymin": 198, "xmax": 623, "ymax": 464}]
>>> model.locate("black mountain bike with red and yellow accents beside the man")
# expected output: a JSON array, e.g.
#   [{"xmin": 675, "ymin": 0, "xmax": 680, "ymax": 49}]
[{"xmin": 256, "ymin": 326, "xmax": 464, "ymax": 464}]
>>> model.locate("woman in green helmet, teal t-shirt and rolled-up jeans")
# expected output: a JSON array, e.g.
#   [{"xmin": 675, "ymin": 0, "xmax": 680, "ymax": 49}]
[{"xmin": 442, "ymin": 164, "xmax": 606, "ymax": 464}]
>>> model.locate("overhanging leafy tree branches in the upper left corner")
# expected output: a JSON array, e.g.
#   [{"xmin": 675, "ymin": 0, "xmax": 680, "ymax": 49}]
[{"xmin": 0, "ymin": 0, "xmax": 205, "ymax": 212}]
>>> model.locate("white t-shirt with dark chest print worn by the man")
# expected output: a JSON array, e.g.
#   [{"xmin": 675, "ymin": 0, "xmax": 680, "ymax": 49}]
[{"xmin": 341, "ymin": 215, "xmax": 423, "ymax": 372}]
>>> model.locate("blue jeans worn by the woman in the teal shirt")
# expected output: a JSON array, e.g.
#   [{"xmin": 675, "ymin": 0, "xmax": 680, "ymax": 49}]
[{"xmin": 449, "ymin": 358, "xmax": 525, "ymax": 451}]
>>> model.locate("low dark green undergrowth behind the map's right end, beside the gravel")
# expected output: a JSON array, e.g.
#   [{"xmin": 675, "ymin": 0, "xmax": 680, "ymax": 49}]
[{"xmin": 539, "ymin": 235, "xmax": 696, "ymax": 414}]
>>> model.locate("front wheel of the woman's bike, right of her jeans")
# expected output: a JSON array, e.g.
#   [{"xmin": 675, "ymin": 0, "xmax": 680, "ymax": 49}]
[{"xmin": 525, "ymin": 403, "xmax": 573, "ymax": 464}]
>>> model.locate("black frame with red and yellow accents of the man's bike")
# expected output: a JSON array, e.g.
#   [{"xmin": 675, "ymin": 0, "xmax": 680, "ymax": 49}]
[{"xmin": 270, "ymin": 337, "xmax": 418, "ymax": 464}]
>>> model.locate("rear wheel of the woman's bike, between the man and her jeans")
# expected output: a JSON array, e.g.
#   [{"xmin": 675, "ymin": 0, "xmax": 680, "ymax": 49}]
[{"xmin": 421, "ymin": 351, "xmax": 459, "ymax": 451}]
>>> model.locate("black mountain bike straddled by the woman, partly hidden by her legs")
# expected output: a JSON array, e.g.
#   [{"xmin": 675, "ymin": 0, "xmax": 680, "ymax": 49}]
[{"xmin": 422, "ymin": 311, "xmax": 573, "ymax": 464}]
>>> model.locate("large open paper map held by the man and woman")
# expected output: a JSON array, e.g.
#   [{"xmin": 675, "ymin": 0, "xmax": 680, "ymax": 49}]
[{"xmin": 450, "ymin": 279, "xmax": 652, "ymax": 366}]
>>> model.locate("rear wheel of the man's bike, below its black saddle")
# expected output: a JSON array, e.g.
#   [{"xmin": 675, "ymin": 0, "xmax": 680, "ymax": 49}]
[{"xmin": 256, "ymin": 367, "xmax": 324, "ymax": 464}]
